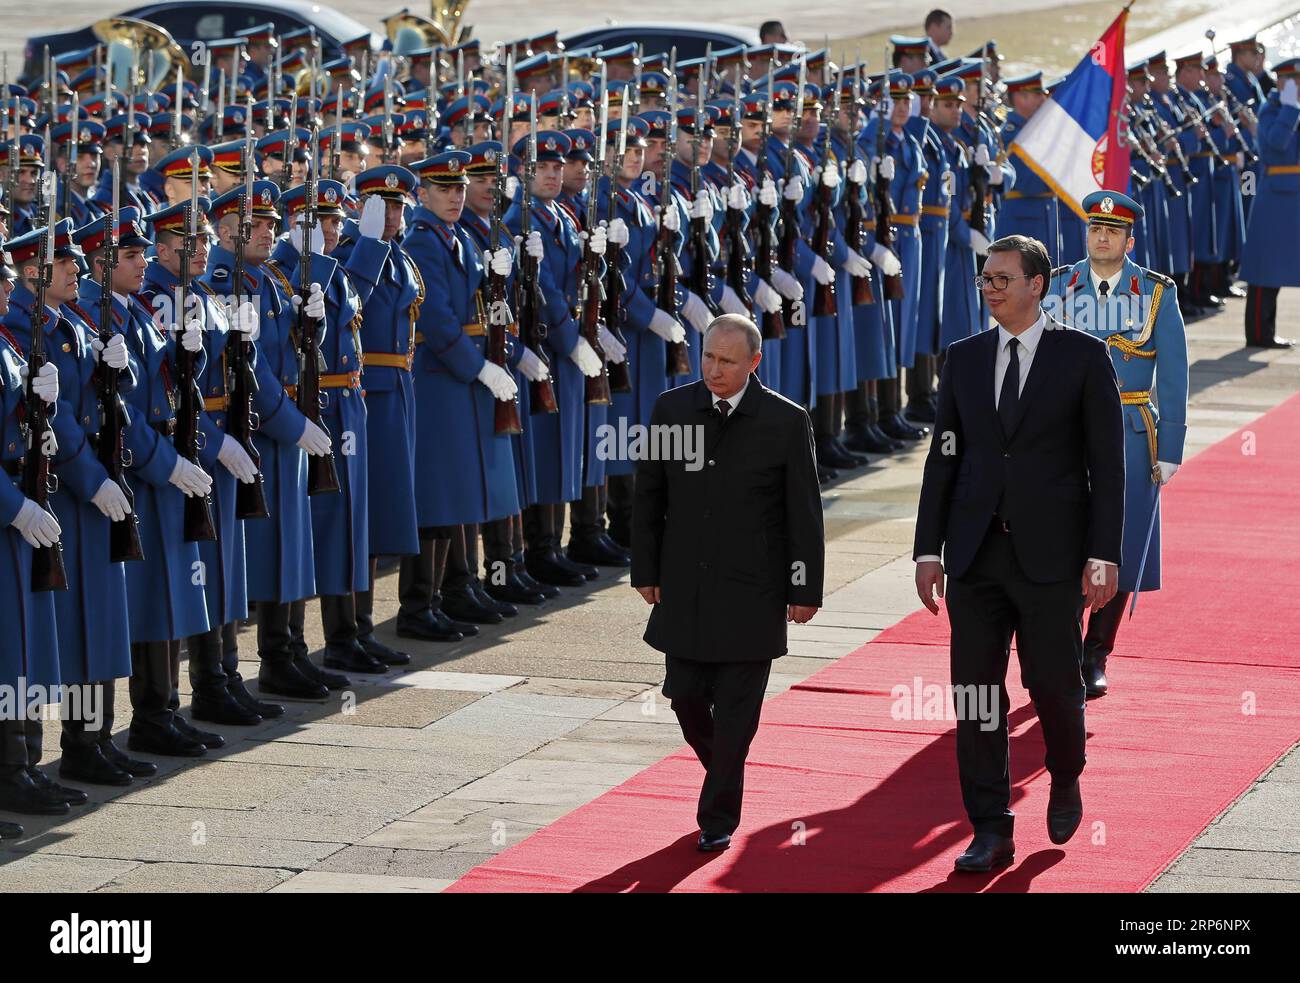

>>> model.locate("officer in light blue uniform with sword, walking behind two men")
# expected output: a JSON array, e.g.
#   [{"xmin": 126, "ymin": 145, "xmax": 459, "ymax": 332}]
[{"xmin": 1044, "ymin": 191, "xmax": 1187, "ymax": 697}]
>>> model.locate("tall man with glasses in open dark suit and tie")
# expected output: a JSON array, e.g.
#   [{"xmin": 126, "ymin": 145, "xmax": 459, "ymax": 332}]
[{"xmin": 913, "ymin": 235, "xmax": 1125, "ymax": 871}]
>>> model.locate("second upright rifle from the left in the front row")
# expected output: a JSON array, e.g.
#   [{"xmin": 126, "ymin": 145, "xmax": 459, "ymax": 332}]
[{"xmin": 95, "ymin": 159, "xmax": 146, "ymax": 563}]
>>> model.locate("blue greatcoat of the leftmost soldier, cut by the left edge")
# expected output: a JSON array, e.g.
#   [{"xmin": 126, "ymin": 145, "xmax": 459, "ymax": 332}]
[{"xmin": 0, "ymin": 327, "xmax": 59, "ymax": 687}]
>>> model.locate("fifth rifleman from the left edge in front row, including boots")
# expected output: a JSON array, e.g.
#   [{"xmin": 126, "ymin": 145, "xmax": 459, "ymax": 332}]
[{"xmin": 207, "ymin": 181, "xmax": 338, "ymax": 700}]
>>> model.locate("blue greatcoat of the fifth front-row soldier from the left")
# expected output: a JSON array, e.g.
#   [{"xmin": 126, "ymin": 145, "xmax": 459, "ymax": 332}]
[{"xmin": 205, "ymin": 246, "xmax": 315, "ymax": 603}]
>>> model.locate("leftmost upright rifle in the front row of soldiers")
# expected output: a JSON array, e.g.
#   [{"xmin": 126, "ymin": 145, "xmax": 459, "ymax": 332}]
[{"xmin": 24, "ymin": 171, "xmax": 68, "ymax": 592}]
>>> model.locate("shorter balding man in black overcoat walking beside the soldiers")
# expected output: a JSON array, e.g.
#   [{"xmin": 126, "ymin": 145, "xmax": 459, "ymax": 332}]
[{"xmin": 632, "ymin": 315, "xmax": 826, "ymax": 850}]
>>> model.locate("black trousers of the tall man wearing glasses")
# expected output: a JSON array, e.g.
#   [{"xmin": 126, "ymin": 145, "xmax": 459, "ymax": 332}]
[{"xmin": 948, "ymin": 523, "xmax": 1086, "ymax": 836}]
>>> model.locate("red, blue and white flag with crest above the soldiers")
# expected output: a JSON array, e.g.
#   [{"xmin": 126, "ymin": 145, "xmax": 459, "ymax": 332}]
[{"xmin": 1010, "ymin": 7, "xmax": 1130, "ymax": 218}]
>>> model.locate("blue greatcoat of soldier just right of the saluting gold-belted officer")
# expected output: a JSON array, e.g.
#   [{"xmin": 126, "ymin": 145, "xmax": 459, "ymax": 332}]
[{"xmin": 402, "ymin": 207, "xmax": 517, "ymax": 527}]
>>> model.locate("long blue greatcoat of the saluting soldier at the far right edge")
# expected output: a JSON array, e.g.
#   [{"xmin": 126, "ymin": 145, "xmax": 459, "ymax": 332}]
[{"xmin": 1240, "ymin": 90, "xmax": 1300, "ymax": 287}]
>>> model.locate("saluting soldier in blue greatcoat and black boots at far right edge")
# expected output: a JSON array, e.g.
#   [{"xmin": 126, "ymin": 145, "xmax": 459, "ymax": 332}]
[{"xmin": 1240, "ymin": 59, "xmax": 1300, "ymax": 348}]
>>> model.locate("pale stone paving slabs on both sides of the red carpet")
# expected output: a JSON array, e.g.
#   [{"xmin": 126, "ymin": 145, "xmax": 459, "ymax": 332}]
[{"xmin": 0, "ymin": 290, "xmax": 1300, "ymax": 892}]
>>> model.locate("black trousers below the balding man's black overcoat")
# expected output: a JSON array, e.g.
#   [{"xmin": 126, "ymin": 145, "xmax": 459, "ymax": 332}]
[{"xmin": 663, "ymin": 655, "xmax": 772, "ymax": 833}]
